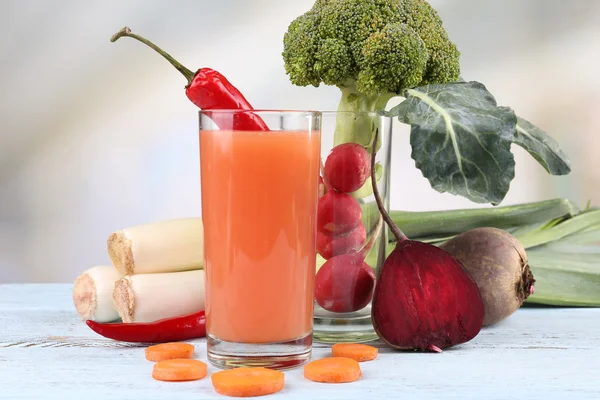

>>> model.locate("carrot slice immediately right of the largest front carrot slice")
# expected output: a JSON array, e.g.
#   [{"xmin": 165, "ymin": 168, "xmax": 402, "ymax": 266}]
[{"xmin": 304, "ymin": 357, "xmax": 362, "ymax": 383}]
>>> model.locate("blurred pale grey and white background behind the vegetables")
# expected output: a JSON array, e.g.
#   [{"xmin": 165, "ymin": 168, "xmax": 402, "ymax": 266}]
[{"xmin": 0, "ymin": 0, "xmax": 600, "ymax": 283}]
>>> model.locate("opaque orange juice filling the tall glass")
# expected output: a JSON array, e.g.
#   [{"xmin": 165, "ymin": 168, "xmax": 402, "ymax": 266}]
[{"xmin": 200, "ymin": 131, "xmax": 320, "ymax": 343}]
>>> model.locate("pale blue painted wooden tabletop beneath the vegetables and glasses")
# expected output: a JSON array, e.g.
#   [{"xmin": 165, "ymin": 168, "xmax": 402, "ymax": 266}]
[{"xmin": 0, "ymin": 284, "xmax": 600, "ymax": 400}]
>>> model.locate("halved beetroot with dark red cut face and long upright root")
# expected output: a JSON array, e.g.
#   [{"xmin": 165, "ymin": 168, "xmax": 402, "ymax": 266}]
[{"xmin": 371, "ymin": 131, "xmax": 484, "ymax": 352}]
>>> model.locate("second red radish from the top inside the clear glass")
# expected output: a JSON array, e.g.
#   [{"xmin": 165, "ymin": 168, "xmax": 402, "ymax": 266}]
[{"xmin": 317, "ymin": 190, "xmax": 362, "ymax": 236}]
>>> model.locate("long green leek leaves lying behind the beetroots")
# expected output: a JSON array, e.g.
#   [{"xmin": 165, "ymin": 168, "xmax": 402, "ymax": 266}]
[{"xmin": 386, "ymin": 199, "xmax": 600, "ymax": 307}]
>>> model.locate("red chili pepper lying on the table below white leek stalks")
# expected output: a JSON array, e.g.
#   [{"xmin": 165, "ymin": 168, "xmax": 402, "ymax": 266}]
[{"xmin": 85, "ymin": 311, "xmax": 206, "ymax": 343}]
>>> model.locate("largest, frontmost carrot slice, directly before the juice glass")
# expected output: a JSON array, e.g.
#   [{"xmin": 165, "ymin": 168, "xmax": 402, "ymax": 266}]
[{"xmin": 211, "ymin": 367, "xmax": 284, "ymax": 397}]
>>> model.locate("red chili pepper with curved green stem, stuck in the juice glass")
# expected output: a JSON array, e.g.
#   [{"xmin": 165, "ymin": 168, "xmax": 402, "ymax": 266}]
[{"xmin": 110, "ymin": 27, "xmax": 269, "ymax": 131}]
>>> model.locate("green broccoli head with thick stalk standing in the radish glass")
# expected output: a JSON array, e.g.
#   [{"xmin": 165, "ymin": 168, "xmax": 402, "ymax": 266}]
[{"xmin": 282, "ymin": 0, "xmax": 460, "ymax": 149}]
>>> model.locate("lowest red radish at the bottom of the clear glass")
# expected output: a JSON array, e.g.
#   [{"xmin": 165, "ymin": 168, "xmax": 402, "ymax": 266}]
[{"xmin": 315, "ymin": 254, "xmax": 375, "ymax": 313}]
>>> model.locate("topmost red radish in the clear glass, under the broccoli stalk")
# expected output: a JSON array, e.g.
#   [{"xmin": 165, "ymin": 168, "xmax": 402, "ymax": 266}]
[{"xmin": 324, "ymin": 143, "xmax": 371, "ymax": 193}]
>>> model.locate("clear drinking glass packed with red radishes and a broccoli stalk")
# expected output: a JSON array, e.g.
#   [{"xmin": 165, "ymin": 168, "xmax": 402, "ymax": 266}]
[{"xmin": 313, "ymin": 111, "xmax": 392, "ymax": 343}]
